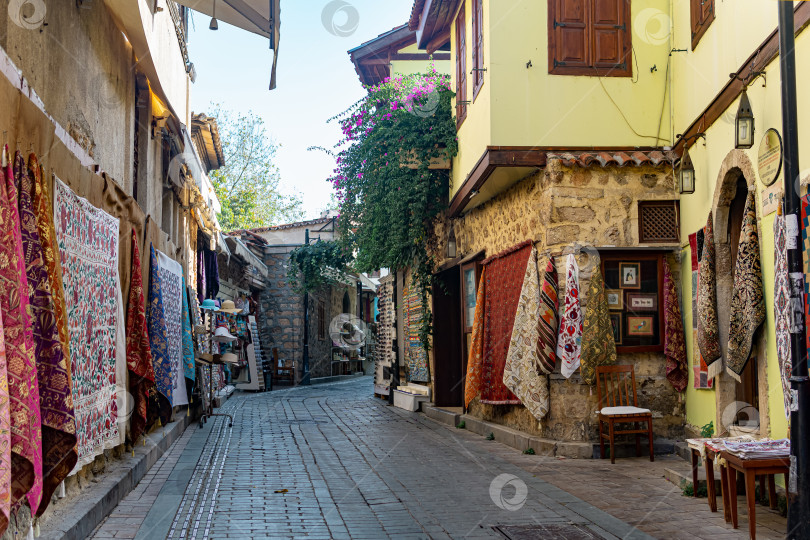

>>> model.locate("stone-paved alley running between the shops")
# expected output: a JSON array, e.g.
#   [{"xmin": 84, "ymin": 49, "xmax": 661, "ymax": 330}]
[{"xmin": 94, "ymin": 377, "xmax": 784, "ymax": 540}]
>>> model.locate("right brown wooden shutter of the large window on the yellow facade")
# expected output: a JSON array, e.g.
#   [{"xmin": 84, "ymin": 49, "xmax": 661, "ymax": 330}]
[{"xmin": 592, "ymin": 0, "xmax": 631, "ymax": 73}]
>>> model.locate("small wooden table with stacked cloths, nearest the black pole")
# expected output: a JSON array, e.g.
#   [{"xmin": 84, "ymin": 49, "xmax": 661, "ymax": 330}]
[{"xmin": 720, "ymin": 451, "xmax": 790, "ymax": 540}]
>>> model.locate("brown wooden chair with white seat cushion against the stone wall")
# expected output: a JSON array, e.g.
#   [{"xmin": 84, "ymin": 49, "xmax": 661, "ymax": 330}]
[{"xmin": 596, "ymin": 366, "xmax": 655, "ymax": 463}]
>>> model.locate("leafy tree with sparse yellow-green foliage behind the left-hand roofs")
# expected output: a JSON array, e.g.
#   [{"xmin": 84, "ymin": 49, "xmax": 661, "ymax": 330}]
[{"xmin": 210, "ymin": 105, "xmax": 303, "ymax": 231}]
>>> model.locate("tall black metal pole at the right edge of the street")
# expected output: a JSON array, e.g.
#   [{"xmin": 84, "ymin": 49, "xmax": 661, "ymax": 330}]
[{"xmin": 777, "ymin": 1, "xmax": 810, "ymax": 539}]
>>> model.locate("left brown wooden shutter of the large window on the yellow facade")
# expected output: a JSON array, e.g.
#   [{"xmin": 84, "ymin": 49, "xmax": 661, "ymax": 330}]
[{"xmin": 549, "ymin": 0, "xmax": 590, "ymax": 71}]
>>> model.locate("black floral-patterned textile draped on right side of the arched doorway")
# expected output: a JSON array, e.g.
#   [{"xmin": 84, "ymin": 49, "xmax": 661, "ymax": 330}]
[{"xmin": 726, "ymin": 191, "xmax": 765, "ymax": 382}]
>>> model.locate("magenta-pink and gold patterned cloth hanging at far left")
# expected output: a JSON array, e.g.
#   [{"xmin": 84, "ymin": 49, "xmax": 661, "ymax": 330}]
[{"xmin": 0, "ymin": 151, "xmax": 42, "ymax": 508}]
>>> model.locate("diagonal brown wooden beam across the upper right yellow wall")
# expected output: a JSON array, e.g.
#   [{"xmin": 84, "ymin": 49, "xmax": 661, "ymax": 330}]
[{"xmin": 673, "ymin": 2, "xmax": 810, "ymax": 154}]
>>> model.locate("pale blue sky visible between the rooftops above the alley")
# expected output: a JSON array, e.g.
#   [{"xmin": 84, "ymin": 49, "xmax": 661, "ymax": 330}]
[{"xmin": 188, "ymin": 0, "xmax": 413, "ymax": 219}]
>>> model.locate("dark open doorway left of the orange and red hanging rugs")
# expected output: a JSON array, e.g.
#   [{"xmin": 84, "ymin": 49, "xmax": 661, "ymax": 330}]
[{"xmin": 433, "ymin": 266, "xmax": 464, "ymax": 407}]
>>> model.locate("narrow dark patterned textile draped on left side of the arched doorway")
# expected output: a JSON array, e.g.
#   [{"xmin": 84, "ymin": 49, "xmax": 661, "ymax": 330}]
[{"xmin": 697, "ymin": 212, "xmax": 722, "ymax": 378}]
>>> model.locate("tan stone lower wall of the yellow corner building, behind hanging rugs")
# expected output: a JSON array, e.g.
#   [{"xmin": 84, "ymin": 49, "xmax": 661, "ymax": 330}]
[{"xmin": 431, "ymin": 161, "xmax": 684, "ymax": 441}]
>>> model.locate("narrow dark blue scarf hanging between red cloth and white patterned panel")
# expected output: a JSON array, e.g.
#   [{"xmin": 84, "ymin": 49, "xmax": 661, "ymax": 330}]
[{"xmin": 149, "ymin": 244, "xmax": 174, "ymax": 425}]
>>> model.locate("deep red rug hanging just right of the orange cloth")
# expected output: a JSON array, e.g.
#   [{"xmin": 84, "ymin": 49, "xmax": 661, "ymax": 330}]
[{"xmin": 480, "ymin": 242, "xmax": 532, "ymax": 405}]
